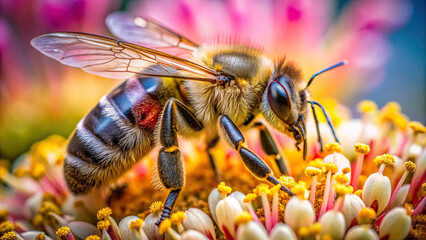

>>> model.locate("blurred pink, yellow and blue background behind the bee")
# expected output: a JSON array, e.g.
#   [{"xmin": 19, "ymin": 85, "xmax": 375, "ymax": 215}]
[{"xmin": 0, "ymin": 0, "xmax": 426, "ymax": 160}]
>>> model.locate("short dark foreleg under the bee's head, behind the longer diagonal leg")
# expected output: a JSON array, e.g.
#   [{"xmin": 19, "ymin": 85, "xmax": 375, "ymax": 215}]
[{"xmin": 254, "ymin": 122, "xmax": 288, "ymax": 175}]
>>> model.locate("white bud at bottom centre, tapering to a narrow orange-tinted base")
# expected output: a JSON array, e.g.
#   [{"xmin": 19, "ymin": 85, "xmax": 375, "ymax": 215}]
[{"xmin": 216, "ymin": 197, "xmax": 243, "ymax": 237}]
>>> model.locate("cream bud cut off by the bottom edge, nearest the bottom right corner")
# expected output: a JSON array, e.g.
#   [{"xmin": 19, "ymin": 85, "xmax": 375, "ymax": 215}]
[{"xmin": 379, "ymin": 207, "xmax": 411, "ymax": 240}]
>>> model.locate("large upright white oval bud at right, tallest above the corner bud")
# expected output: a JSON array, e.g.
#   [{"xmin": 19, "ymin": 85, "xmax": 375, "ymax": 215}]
[{"xmin": 362, "ymin": 173, "xmax": 391, "ymax": 214}]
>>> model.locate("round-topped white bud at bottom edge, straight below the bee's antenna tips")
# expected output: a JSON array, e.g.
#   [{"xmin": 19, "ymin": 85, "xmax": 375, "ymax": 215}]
[{"xmin": 319, "ymin": 210, "xmax": 346, "ymax": 240}]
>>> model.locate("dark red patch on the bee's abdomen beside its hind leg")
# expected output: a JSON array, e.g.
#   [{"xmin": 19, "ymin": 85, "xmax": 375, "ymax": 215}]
[{"xmin": 132, "ymin": 95, "xmax": 162, "ymax": 132}]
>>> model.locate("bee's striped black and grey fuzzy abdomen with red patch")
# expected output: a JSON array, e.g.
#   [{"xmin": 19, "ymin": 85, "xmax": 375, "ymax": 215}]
[{"xmin": 64, "ymin": 78, "xmax": 176, "ymax": 193}]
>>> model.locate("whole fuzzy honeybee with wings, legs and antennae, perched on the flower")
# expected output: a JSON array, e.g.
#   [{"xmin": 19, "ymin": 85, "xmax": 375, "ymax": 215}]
[{"xmin": 31, "ymin": 13, "xmax": 345, "ymax": 221}]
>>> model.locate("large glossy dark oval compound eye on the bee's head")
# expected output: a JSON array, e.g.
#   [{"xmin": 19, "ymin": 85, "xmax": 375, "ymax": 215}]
[{"xmin": 267, "ymin": 81, "xmax": 291, "ymax": 122}]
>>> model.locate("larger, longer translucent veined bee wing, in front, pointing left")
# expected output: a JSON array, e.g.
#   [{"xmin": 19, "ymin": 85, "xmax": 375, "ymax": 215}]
[{"xmin": 31, "ymin": 32, "xmax": 217, "ymax": 82}]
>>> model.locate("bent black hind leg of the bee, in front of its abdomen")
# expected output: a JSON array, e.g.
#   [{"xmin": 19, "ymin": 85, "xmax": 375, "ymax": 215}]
[{"xmin": 156, "ymin": 99, "xmax": 203, "ymax": 225}]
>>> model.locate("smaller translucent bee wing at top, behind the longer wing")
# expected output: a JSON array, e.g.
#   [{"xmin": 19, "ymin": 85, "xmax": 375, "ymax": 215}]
[{"xmin": 105, "ymin": 12, "xmax": 199, "ymax": 53}]
